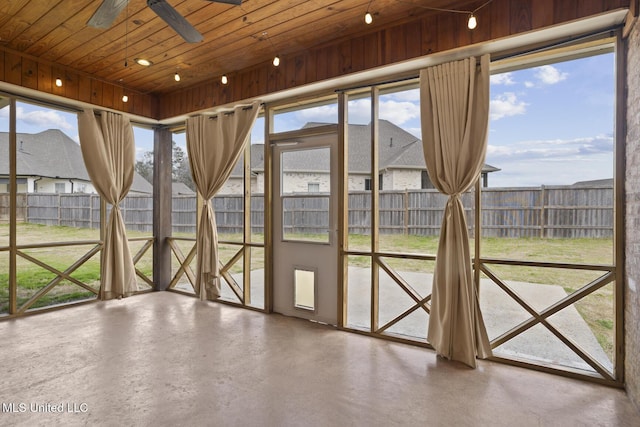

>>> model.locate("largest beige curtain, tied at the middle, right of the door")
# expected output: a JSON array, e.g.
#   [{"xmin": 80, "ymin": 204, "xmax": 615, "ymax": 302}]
[{"xmin": 420, "ymin": 55, "xmax": 491, "ymax": 368}]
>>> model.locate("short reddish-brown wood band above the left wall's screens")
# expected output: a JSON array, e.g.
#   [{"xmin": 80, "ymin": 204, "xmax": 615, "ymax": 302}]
[{"xmin": 0, "ymin": 48, "xmax": 159, "ymax": 118}]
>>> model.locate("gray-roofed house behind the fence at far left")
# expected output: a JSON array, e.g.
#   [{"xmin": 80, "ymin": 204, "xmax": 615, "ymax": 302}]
[{"xmin": 0, "ymin": 129, "xmax": 153, "ymax": 194}]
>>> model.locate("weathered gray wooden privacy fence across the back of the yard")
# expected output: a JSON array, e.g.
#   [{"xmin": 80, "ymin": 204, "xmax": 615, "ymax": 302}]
[{"xmin": 0, "ymin": 186, "xmax": 614, "ymax": 238}]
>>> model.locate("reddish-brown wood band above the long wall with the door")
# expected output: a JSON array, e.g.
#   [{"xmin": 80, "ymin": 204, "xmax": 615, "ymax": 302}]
[{"xmin": 159, "ymin": 0, "xmax": 629, "ymax": 119}]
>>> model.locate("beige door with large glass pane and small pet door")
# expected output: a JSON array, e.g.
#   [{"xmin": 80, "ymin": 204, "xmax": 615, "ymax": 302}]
[{"xmin": 271, "ymin": 125, "xmax": 338, "ymax": 325}]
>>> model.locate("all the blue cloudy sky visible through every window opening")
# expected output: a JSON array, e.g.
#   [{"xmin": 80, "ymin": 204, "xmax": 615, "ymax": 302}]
[{"xmin": 0, "ymin": 54, "xmax": 615, "ymax": 187}]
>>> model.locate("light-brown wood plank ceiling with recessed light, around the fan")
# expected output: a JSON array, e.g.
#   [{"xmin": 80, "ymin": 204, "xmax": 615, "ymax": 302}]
[{"xmin": 0, "ymin": 0, "xmax": 486, "ymax": 94}]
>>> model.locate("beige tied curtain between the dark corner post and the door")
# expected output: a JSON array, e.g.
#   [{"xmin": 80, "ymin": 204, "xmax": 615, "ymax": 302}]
[{"xmin": 187, "ymin": 102, "xmax": 260, "ymax": 300}]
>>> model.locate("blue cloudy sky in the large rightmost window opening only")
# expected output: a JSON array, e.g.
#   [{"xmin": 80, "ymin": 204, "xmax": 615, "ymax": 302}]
[{"xmin": 486, "ymin": 54, "xmax": 615, "ymax": 186}]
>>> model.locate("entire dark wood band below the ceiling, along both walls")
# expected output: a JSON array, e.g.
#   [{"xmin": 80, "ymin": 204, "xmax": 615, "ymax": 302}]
[{"xmin": 0, "ymin": 0, "xmax": 637, "ymax": 119}]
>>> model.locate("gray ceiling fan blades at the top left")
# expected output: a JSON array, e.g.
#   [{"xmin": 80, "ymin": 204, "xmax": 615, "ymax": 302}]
[{"xmin": 87, "ymin": 0, "xmax": 242, "ymax": 43}]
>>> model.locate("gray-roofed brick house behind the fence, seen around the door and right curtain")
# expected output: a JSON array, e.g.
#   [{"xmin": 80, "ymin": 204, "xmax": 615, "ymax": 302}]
[{"xmin": 219, "ymin": 120, "xmax": 500, "ymax": 194}]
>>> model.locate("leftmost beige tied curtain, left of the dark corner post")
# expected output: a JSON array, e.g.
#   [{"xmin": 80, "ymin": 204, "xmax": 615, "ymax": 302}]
[{"xmin": 78, "ymin": 109, "xmax": 137, "ymax": 300}]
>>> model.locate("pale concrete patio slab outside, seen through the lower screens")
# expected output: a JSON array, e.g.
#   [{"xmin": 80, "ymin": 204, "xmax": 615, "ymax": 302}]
[{"xmin": 208, "ymin": 266, "xmax": 613, "ymax": 372}]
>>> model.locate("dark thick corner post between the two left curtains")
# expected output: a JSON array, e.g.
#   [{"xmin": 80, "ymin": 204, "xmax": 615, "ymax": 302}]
[{"xmin": 153, "ymin": 126, "xmax": 173, "ymax": 291}]
